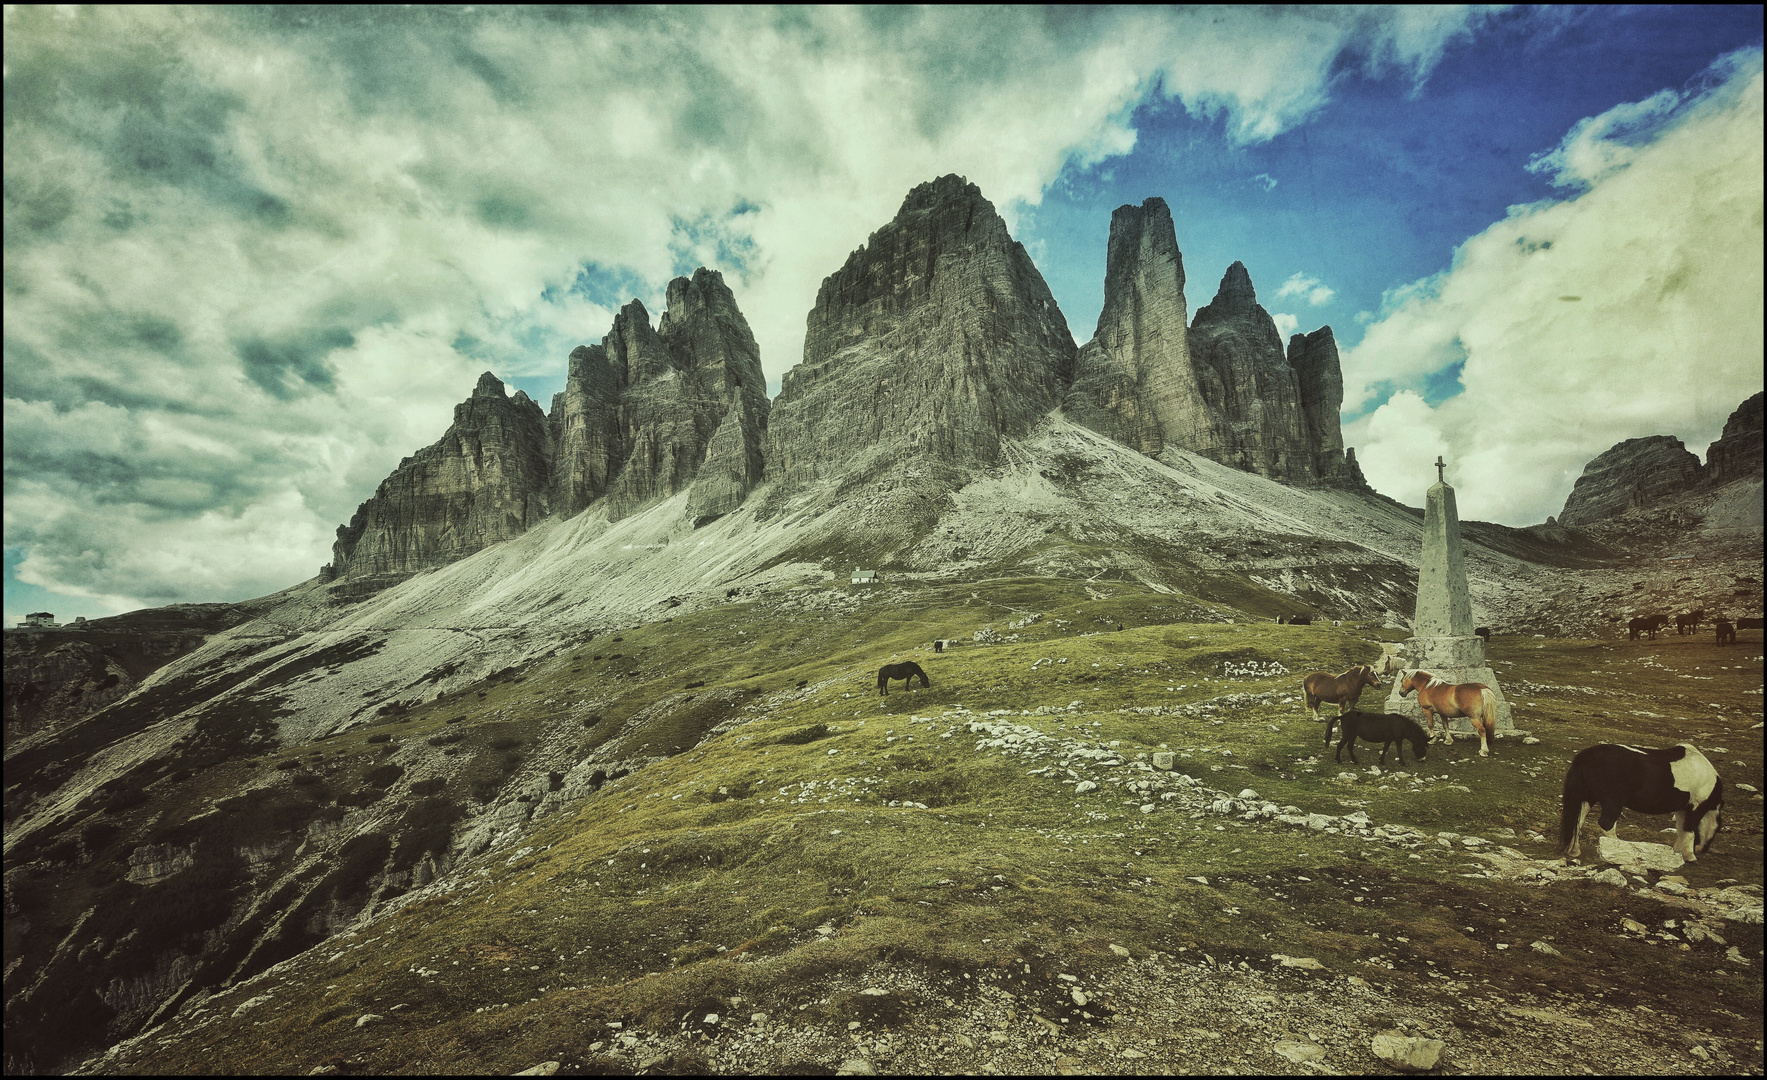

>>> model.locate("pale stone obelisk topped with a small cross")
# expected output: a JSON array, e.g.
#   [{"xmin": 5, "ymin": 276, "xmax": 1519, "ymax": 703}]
[{"xmin": 1387, "ymin": 458, "xmax": 1516, "ymax": 732}]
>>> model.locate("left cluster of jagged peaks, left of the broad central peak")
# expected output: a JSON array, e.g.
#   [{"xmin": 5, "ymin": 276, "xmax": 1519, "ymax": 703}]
[{"xmin": 327, "ymin": 267, "xmax": 769, "ymax": 576}]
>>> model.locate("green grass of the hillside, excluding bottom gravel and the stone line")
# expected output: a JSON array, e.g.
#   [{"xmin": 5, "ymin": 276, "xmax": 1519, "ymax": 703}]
[{"xmin": 117, "ymin": 576, "xmax": 1762, "ymax": 1071}]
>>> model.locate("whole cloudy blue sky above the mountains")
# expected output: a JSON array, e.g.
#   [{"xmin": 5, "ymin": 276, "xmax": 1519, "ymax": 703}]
[{"xmin": 4, "ymin": 7, "xmax": 1762, "ymax": 622}]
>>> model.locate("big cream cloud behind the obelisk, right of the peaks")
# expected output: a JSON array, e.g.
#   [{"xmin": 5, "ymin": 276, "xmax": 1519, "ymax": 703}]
[{"xmin": 1345, "ymin": 49, "xmax": 1763, "ymax": 525}]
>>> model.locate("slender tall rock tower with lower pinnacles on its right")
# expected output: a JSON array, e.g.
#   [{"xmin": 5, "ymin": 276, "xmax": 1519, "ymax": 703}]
[{"xmin": 1062, "ymin": 198, "xmax": 1366, "ymax": 488}]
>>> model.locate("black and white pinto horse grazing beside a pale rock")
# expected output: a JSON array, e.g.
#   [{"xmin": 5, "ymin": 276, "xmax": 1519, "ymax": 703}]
[{"xmin": 1558, "ymin": 742, "xmax": 1725, "ymax": 863}]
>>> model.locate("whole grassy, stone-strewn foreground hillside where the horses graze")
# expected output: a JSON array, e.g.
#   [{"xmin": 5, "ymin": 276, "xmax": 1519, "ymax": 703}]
[{"xmin": 55, "ymin": 578, "xmax": 1762, "ymax": 1073}]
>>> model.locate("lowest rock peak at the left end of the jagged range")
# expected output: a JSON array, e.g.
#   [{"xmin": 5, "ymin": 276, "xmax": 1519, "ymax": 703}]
[{"xmin": 332, "ymin": 371, "xmax": 550, "ymax": 576}]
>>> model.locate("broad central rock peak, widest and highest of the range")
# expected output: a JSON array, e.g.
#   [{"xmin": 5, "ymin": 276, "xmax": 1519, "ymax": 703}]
[{"xmin": 765, "ymin": 177, "xmax": 1076, "ymax": 490}]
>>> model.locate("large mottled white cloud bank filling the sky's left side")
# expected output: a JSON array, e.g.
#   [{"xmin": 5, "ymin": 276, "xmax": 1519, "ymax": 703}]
[{"xmin": 5, "ymin": 7, "xmax": 1484, "ymax": 605}]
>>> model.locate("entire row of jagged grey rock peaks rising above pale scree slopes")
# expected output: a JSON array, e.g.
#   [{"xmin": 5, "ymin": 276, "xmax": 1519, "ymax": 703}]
[{"xmin": 325, "ymin": 175, "xmax": 1364, "ymax": 582}]
